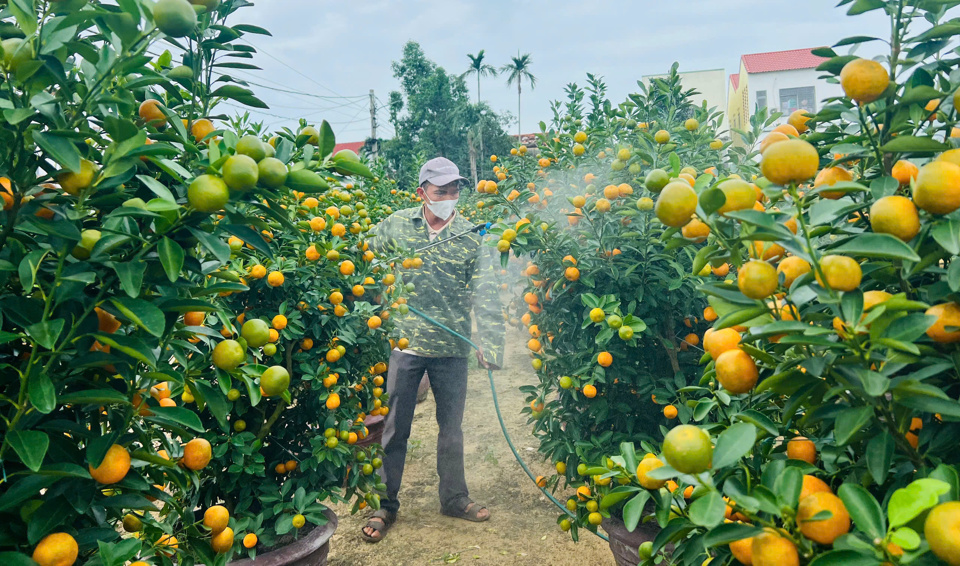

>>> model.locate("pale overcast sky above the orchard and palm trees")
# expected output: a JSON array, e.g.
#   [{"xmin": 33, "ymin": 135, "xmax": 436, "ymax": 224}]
[{"xmin": 221, "ymin": 0, "xmax": 889, "ymax": 142}]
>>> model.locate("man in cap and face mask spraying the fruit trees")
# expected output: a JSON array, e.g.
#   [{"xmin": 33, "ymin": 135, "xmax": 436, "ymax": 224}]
[{"xmin": 361, "ymin": 157, "xmax": 504, "ymax": 542}]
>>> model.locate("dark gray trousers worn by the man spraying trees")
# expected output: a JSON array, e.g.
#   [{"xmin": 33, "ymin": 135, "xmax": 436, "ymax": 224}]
[{"xmin": 380, "ymin": 352, "xmax": 470, "ymax": 513}]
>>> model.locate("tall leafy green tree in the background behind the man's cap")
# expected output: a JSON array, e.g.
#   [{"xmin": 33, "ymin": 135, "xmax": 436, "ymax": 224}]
[{"xmin": 384, "ymin": 41, "xmax": 512, "ymax": 193}]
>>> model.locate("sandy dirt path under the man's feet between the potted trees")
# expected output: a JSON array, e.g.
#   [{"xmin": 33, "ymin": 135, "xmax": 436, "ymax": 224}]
[{"xmin": 330, "ymin": 331, "xmax": 614, "ymax": 566}]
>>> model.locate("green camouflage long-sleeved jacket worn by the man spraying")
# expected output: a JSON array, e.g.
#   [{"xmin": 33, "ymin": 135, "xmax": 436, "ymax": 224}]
[{"xmin": 370, "ymin": 207, "xmax": 504, "ymax": 367}]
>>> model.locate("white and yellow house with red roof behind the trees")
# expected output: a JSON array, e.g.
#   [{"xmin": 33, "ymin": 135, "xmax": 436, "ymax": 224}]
[{"xmin": 727, "ymin": 48, "xmax": 842, "ymax": 142}]
